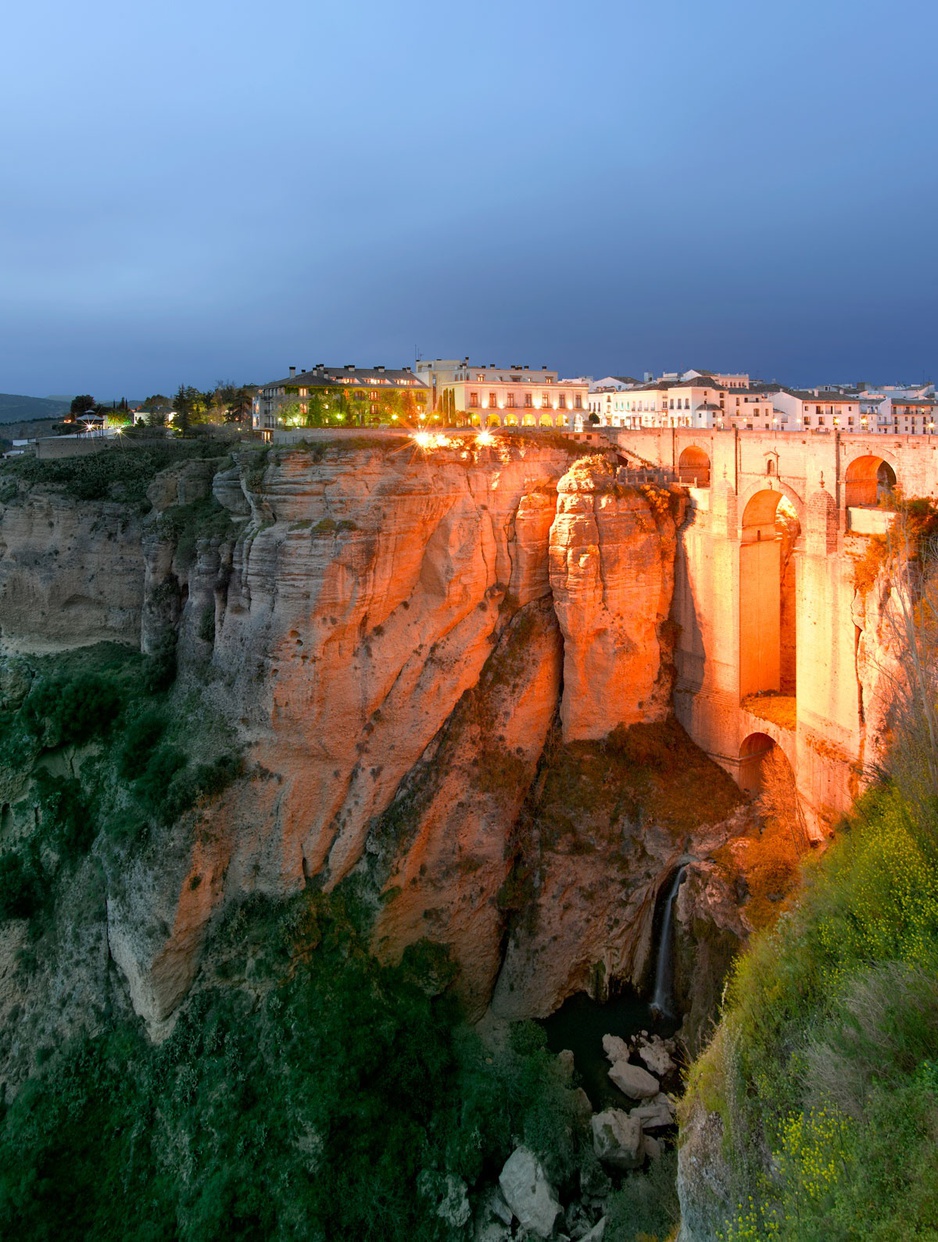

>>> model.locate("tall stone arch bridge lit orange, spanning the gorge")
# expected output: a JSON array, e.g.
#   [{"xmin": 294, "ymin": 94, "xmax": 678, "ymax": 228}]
[{"xmin": 604, "ymin": 428, "xmax": 938, "ymax": 836}]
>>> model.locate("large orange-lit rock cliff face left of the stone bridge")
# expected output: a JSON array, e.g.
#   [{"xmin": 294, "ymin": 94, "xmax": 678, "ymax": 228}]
[{"xmin": 0, "ymin": 438, "xmax": 733, "ymax": 1035}]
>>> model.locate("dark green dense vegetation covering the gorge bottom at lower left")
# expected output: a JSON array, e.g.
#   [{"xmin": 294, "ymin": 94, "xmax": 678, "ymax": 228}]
[{"xmin": 0, "ymin": 894, "xmax": 593, "ymax": 1242}]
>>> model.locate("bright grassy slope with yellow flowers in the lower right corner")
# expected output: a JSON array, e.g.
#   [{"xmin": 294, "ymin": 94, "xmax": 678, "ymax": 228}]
[{"xmin": 685, "ymin": 787, "xmax": 938, "ymax": 1242}]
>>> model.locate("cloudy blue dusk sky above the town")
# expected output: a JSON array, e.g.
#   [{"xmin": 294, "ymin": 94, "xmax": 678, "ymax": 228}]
[{"xmin": 0, "ymin": 0, "xmax": 938, "ymax": 399}]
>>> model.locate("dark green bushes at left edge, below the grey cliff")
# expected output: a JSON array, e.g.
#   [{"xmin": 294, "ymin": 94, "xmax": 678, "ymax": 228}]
[{"xmin": 0, "ymin": 643, "xmax": 241, "ymax": 936}]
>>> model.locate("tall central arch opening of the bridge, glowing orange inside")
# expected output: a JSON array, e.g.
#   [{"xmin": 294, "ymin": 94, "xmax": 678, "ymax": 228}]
[{"xmin": 739, "ymin": 489, "xmax": 801, "ymax": 714}]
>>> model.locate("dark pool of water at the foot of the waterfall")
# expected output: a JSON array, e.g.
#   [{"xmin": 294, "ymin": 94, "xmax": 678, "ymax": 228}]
[{"xmin": 540, "ymin": 989, "xmax": 681, "ymax": 1109}]
